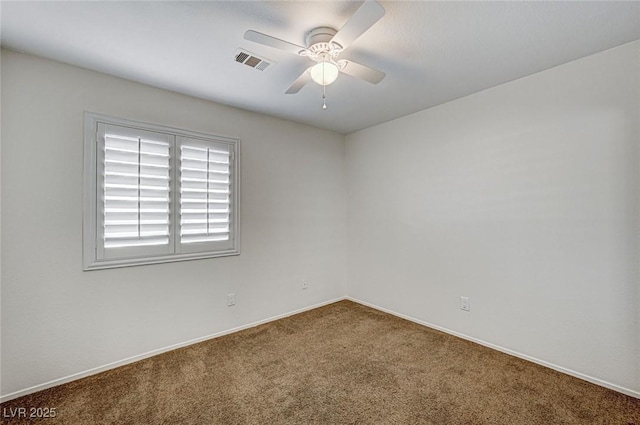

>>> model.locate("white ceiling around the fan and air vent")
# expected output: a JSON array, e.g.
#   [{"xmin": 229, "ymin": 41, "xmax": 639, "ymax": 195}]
[{"xmin": 1, "ymin": 1, "xmax": 640, "ymax": 134}]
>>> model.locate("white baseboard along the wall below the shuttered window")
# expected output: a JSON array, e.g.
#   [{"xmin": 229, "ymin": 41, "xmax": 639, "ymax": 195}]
[{"xmin": 0, "ymin": 297, "xmax": 346, "ymax": 403}]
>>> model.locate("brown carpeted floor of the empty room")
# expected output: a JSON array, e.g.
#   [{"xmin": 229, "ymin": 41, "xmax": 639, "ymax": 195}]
[{"xmin": 2, "ymin": 301, "xmax": 640, "ymax": 425}]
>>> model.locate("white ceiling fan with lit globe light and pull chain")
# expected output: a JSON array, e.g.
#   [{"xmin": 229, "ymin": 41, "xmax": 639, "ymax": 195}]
[{"xmin": 244, "ymin": 0, "xmax": 385, "ymax": 109}]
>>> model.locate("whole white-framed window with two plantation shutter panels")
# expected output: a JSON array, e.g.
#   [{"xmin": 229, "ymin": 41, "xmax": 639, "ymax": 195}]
[{"xmin": 84, "ymin": 113, "xmax": 240, "ymax": 270}]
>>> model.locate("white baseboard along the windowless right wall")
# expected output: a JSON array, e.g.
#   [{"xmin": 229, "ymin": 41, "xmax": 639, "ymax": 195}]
[{"xmin": 345, "ymin": 296, "xmax": 640, "ymax": 399}]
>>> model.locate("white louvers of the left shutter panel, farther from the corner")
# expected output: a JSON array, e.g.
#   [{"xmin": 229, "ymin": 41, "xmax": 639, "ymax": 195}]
[{"xmin": 103, "ymin": 134, "xmax": 171, "ymax": 249}]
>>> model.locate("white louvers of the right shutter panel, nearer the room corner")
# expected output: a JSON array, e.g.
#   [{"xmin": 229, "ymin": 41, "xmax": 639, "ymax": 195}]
[{"xmin": 180, "ymin": 143, "xmax": 231, "ymax": 244}]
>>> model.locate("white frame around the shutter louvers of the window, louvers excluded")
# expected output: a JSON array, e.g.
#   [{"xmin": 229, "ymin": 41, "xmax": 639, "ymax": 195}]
[{"xmin": 83, "ymin": 112, "xmax": 240, "ymax": 271}]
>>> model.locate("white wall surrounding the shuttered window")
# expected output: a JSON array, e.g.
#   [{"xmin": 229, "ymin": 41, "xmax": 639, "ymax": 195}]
[{"xmin": 1, "ymin": 51, "xmax": 346, "ymax": 396}]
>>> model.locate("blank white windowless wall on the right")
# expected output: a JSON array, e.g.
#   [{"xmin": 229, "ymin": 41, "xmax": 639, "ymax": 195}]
[{"xmin": 346, "ymin": 42, "xmax": 640, "ymax": 396}]
